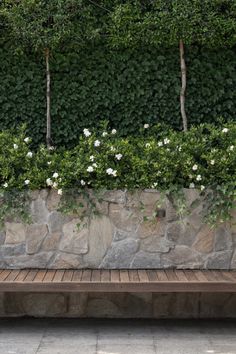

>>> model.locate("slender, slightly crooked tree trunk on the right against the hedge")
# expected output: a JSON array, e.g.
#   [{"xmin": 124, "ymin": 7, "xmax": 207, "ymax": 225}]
[{"xmin": 179, "ymin": 39, "xmax": 188, "ymax": 132}]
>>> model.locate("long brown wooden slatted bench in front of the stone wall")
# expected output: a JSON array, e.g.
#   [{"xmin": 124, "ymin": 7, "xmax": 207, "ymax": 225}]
[{"xmin": 0, "ymin": 269, "xmax": 236, "ymax": 292}]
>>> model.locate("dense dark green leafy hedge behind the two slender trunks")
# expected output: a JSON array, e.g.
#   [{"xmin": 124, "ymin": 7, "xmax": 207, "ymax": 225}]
[{"xmin": 0, "ymin": 46, "xmax": 236, "ymax": 146}]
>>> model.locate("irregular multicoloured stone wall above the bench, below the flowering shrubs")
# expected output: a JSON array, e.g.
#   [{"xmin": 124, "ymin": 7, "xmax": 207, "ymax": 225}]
[{"xmin": 0, "ymin": 190, "xmax": 236, "ymax": 270}]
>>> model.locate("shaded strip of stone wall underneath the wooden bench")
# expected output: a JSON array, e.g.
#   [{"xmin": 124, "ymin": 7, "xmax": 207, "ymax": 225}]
[{"xmin": 0, "ymin": 293, "xmax": 236, "ymax": 318}]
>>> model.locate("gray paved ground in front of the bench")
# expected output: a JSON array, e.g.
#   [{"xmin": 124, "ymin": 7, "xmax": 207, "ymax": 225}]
[{"xmin": 0, "ymin": 319, "xmax": 236, "ymax": 354}]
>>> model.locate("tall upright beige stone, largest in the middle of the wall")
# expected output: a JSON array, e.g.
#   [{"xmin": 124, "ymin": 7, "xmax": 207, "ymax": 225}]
[{"xmin": 84, "ymin": 216, "xmax": 114, "ymax": 267}]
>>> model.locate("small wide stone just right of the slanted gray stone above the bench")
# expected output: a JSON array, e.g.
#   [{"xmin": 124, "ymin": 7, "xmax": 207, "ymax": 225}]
[{"xmin": 140, "ymin": 236, "xmax": 173, "ymax": 253}]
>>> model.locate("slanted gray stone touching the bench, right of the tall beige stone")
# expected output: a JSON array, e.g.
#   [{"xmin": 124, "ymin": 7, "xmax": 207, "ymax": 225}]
[{"xmin": 99, "ymin": 239, "xmax": 139, "ymax": 269}]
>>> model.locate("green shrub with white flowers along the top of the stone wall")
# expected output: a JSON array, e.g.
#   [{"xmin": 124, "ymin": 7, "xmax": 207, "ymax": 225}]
[{"xmin": 0, "ymin": 123, "xmax": 236, "ymax": 221}]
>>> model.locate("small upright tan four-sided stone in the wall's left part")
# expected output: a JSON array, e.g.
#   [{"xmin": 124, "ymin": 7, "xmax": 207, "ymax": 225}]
[{"xmin": 26, "ymin": 224, "xmax": 48, "ymax": 254}]
